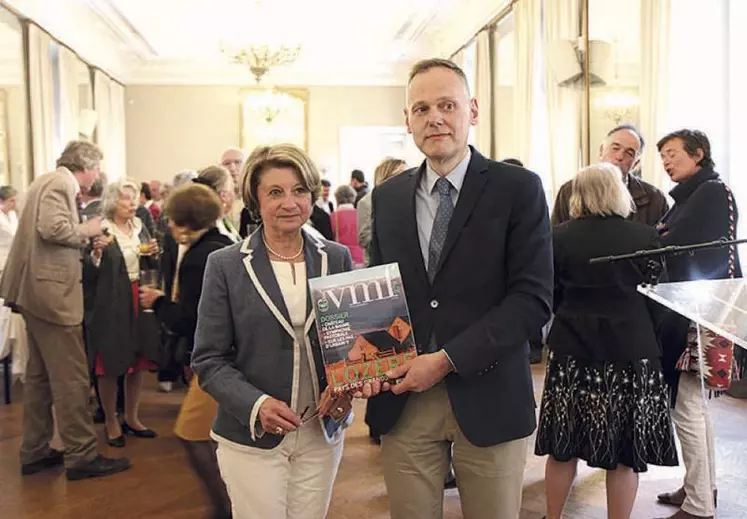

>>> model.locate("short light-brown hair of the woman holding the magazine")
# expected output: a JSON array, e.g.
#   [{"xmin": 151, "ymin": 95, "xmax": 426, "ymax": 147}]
[{"xmin": 239, "ymin": 144, "xmax": 322, "ymax": 217}]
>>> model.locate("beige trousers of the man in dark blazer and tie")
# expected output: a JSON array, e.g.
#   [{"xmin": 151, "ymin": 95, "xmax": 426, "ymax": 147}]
[{"xmin": 381, "ymin": 383, "xmax": 528, "ymax": 519}]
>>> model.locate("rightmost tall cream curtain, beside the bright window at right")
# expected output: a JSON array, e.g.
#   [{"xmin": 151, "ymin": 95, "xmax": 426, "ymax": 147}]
[{"xmin": 640, "ymin": 0, "xmax": 671, "ymax": 190}]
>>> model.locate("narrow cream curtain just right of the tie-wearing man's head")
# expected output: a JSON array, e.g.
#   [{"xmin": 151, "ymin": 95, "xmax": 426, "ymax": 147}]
[{"xmin": 474, "ymin": 29, "xmax": 495, "ymax": 159}]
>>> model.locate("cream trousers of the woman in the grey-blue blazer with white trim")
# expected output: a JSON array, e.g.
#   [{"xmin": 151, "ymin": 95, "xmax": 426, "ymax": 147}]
[{"xmin": 216, "ymin": 420, "xmax": 343, "ymax": 519}]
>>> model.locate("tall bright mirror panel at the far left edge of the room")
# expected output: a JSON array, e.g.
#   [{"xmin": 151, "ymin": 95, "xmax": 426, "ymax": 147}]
[{"xmin": 0, "ymin": 6, "xmax": 29, "ymax": 191}]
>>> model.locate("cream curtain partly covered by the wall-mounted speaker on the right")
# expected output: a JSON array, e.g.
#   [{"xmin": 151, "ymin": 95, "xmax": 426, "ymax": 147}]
[{"xmin": 543, "ymin": 0, "xmax": 584, "ymax": 193}]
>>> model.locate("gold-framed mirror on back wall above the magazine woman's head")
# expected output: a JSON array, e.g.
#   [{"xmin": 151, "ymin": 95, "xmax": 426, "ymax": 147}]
[{"xmin": 240, "ymin": 88, "xmax": 309, "ymax": 153}]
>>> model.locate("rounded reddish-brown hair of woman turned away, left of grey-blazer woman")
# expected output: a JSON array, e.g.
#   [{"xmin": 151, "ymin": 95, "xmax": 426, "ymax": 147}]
[{"xmin": 166, "ymin": 183, "xmax": 221, "ymax": 231}]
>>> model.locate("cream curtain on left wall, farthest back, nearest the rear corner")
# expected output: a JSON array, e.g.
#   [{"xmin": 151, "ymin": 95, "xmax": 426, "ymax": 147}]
[{"xmin": 93, "ymin": 70, "xmax": 126, "ymax": 181}]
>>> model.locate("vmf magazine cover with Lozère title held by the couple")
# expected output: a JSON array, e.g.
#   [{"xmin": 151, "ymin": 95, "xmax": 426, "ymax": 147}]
[{"xmin": 309, "ymin": 263, "xmax": 417, "ymax": 391}]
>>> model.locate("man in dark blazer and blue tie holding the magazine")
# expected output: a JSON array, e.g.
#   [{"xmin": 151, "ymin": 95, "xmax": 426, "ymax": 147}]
[{"xmin": 368, "ymin": 59, "xmax": 553, "ymax": 519}]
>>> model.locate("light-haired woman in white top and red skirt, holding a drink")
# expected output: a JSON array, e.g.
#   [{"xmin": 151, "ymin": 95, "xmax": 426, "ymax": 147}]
[{"xmin": 83, "ymin": 181, "xmax": 158, "ymax": 447}]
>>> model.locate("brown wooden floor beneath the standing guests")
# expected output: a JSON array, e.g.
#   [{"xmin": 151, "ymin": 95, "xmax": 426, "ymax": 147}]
[{"xmin": 0, "ymin": 366, "xmax": 747, "ymax": 519}]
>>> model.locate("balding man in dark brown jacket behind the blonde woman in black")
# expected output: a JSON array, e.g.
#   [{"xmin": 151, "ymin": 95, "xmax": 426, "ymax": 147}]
[{"xmin": 552, "ymin": 124, "xmax": 669, "ymax": 226}]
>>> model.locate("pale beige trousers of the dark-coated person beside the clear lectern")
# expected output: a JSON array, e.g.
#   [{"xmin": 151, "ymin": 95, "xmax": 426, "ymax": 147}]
[{"xmin": 672, "ymin": 373, "xmax": 716, "ymax": 517}]
